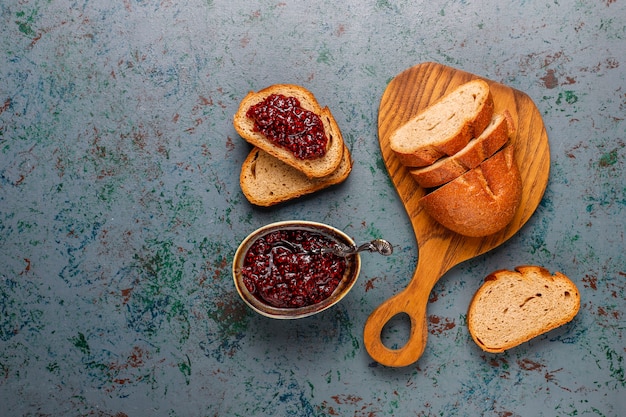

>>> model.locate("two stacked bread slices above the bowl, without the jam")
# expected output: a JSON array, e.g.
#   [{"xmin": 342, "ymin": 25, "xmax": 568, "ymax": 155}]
[{"xmin": 233, "ymin": 84, "xmax": 352, "ymax": 207}]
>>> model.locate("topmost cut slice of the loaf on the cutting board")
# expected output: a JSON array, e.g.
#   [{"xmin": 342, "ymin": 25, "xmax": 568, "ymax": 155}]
[{"xmin": 389, "ymin": 79, "xmax": 494, "ymax": 167}]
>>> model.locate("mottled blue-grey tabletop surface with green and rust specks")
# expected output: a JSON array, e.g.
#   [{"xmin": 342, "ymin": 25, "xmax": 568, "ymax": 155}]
[{"xmin": 0, "ymin": 0, "xmax": 626, "ymax": 417}]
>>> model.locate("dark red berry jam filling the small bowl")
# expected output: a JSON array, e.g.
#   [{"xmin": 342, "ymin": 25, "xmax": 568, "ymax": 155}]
[{"xmin": 241, "ymin": 230, "xmax": 346, "ymax": 308}]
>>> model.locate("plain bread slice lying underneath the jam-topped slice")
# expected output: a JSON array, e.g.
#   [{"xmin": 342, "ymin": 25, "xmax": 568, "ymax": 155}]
[{"xmin": 239, "ymin": 147, "xmax": 352, "ymax": 207}]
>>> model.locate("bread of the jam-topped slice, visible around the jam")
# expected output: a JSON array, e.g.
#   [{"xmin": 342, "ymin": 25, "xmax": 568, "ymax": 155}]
[{"xmin": 233, "ymin": 84, "xmax": 344, "ymax": 178}]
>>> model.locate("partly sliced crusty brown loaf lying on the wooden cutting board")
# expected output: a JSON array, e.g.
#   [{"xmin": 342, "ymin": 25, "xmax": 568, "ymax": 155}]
[{"xmin": 389, "ymin": 79, "xmax": 522, "ymax": 237}]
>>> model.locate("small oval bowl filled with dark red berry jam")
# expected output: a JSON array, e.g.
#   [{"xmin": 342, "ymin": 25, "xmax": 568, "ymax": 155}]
[{"xmin": 233, "ymin": 220, "xmax": 361, "ymax": 319}]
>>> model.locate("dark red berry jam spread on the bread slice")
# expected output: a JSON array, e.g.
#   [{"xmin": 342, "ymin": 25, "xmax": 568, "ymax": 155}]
[{"xmin": 246, "ymin": 94, "xmax": 328, "ymax": 159}]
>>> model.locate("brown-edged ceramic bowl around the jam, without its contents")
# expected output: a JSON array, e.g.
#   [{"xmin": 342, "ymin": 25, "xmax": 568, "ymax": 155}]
[{"xmin": 232, "ymin": 220, "xmax": 361, "ymax": 319}]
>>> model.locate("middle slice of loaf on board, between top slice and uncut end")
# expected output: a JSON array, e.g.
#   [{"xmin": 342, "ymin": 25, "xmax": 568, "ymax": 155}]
[{"xmin": 409, "ymin": 110, "xmax": 515, "ymax": 188}]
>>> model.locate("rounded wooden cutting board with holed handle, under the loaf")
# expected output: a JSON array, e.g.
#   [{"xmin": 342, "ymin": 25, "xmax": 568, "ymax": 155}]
[{"xmin": 364, "ymin": 62, "xmax": 550, "ymax": 366}]
